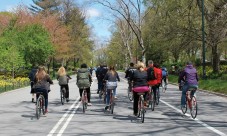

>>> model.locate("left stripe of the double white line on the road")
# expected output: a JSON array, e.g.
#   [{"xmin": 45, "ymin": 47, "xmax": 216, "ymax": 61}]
[{"xmin": 47, "ymin": 97, "xmax": 80, "ymax": 136}]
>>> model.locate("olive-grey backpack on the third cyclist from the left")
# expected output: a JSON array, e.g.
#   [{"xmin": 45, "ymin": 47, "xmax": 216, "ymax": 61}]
[{"xmin": 77, "ymin": 71, "xmax": 91, "ymax": 89}]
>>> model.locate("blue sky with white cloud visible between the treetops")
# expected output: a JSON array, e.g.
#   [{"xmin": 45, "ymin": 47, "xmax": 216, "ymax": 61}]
[{"xmin": 0, "ymin": 0, "xmax": 111, "ymax": 43}]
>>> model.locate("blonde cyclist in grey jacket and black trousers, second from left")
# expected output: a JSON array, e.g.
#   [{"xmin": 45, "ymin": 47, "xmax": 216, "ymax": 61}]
[{"xmin": 57, "ymin": 66, "xmax": 72, "ymax": 102}]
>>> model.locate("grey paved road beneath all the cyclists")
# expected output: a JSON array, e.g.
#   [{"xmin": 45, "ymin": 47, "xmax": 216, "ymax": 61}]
[{"xmin": 0, "ymin": 75, "xmax": 227, "ymax": 136}]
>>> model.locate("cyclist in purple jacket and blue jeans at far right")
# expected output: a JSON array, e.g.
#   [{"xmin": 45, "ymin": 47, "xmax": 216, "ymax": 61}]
[{"xmin": 179, "ymin": 61, "xmax": 199, "ymax": 107}]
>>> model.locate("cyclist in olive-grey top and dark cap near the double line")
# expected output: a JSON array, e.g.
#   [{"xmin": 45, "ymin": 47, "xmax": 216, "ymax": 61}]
[{"xmin": 76, "ymin": 63, "xmax": 92, "ymax": 106}]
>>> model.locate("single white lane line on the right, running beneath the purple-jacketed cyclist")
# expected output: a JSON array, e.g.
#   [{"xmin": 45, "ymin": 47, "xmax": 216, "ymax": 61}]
[{"xmin": 160, "ymin": 100, "xmax": 227, "ymax": 136}]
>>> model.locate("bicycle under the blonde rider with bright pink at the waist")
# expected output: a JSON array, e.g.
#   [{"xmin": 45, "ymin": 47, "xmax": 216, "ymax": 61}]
[{"xmin": 137, "ymin": 93, "xmax": 146, "ymax": 123}]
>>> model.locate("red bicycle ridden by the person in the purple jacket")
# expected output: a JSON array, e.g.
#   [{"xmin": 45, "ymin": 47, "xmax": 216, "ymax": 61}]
[{"xmin": 181, "ymin": 88, "xmax": 198, "ymax": 119}]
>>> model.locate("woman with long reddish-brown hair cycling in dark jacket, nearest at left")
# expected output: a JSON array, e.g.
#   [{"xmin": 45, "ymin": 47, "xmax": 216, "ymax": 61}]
[{"xmin": 33, "ymin": 66, "xmax": 53, "ymax": 113}]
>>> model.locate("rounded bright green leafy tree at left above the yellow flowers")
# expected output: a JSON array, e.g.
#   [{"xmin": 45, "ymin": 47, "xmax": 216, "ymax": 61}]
[{"xmin": 16, "ymin": 24, "xmax": 54, "ymax": 65}]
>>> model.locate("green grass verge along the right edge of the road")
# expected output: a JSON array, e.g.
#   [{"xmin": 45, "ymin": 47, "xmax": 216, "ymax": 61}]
[{"xmin": 169, "ymin": 75, "xmax": 227, "ymax": 94}]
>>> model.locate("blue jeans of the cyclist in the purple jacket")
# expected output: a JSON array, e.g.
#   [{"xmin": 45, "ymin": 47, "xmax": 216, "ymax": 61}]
[{"xmin": 181, "ymin": 83, "xmax": 198, "ymax": 106}]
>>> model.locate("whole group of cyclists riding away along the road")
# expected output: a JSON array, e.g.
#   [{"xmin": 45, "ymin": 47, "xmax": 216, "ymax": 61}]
[{"xmin": 29, "ymin": 60, "xmax": 198, "ymax": 116}]
